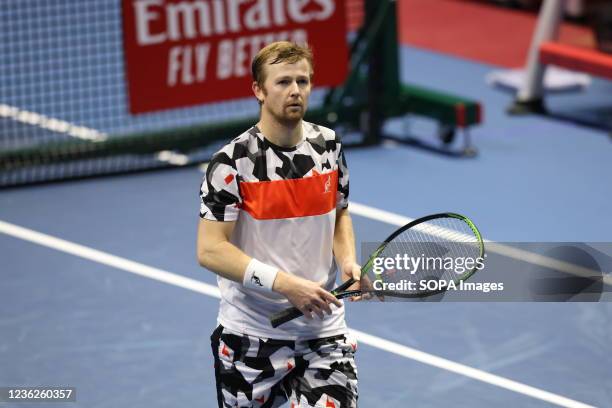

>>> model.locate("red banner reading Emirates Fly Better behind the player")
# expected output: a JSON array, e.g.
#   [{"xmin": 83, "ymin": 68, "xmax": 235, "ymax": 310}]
[{"xmin": 123, "ymin": 0, "xmax": 348, "ymax": 113}]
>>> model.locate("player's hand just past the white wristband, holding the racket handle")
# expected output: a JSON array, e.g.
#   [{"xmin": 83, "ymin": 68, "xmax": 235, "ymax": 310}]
[{"xmin": 272, "ymin": 271, "xmax": 342, "ymax": 319}]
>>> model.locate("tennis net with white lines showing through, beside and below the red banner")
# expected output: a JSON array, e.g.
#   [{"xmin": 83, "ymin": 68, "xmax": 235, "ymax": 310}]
[{"xmin": 0, "ymin": 0, "xmax": 363, "ymax": 188}]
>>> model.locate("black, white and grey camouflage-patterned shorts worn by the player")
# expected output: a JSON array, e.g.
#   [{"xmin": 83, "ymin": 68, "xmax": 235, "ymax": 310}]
[{"xmin": 211, "ymin": 326, "xmax": 357, "ymax": 408}]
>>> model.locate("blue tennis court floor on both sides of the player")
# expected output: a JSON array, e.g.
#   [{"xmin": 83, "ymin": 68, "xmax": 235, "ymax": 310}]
[{"xmin": 0, "ymin": 47, "xmax": 612, "ymax": 407}]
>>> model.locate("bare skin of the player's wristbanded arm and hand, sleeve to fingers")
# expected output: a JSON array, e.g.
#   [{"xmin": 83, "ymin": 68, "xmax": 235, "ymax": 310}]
[{"xmin": 197, "ymin": 219, "xmax": 342, "ymax": 318}]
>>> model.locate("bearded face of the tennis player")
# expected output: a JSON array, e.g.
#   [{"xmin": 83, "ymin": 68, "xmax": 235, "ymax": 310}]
[{"xmin": 253, "ymin": 59, "xmax": 311, "ymax": 125}]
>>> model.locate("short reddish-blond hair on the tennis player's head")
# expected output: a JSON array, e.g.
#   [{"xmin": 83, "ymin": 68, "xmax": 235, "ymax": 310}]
[{"xmin": 251, "ymin": 41, "xmax": 314, "ymax": 88}]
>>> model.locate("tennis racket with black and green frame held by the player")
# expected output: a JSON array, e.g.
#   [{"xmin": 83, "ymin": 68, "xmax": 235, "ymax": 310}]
[{"xmin": 270, "ymin": 213, "xmax": 485, "ymax": 327}]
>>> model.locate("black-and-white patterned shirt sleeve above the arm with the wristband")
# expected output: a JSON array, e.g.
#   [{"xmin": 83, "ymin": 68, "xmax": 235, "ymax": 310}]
[{"xmin": 200, "ymin": 151, "xmax": 241, "ymax": 221}]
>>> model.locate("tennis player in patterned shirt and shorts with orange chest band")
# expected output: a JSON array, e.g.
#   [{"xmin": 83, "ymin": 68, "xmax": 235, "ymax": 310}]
[{"xmin": 197, "ymin": 42, "xmax": 360, "ymax": 408}]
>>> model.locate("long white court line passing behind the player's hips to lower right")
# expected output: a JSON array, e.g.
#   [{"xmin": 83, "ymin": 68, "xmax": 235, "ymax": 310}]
[{"xmin": 0, "ymin": 220, "xmax": 594, "ymax": 408}]
